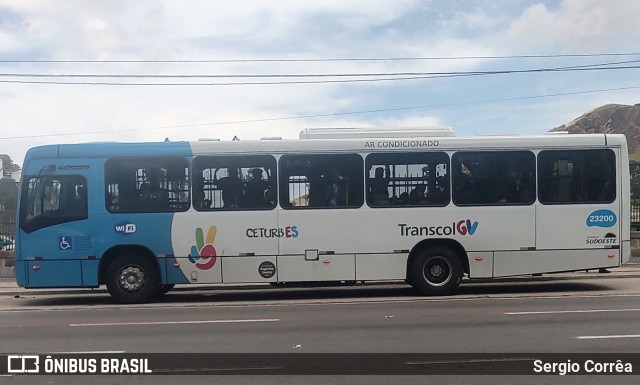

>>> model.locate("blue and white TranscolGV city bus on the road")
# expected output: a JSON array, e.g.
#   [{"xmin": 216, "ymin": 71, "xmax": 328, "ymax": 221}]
[{"xmin": 15, "ymin": 129, "xmax": 631, "ymax": 303}]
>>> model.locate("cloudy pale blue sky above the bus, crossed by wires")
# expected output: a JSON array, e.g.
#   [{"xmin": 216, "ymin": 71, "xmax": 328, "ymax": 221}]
[{"xmin": 0, "ymin": 0, "xmax": 640, "ymax": 164}]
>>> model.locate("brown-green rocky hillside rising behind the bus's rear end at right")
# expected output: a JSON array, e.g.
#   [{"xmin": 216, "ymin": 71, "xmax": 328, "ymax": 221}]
[{"xmin": 551, "ymin": 104, "xmax": 640, "ymax": 160}]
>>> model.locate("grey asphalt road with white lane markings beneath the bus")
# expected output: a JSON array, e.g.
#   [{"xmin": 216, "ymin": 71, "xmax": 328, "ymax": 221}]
[{"xmin": 0, "ymin": 278, "xmax": 640, "ymax": 385}]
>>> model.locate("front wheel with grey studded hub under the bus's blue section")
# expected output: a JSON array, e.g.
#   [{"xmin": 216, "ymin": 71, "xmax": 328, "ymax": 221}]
[{"xmin": 106, "ymin": 255, "xmax": 161, "ymax": 303}]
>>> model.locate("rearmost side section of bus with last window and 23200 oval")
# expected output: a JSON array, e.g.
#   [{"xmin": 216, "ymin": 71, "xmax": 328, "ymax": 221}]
[{"xmin": 536, "ymin": 149, "xmax": 622, "ymax": 271}]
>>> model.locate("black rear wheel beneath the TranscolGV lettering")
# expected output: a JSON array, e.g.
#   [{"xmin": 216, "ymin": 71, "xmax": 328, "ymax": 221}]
[{"xmin": 408, "ymin": 247, "xmax": 464, "ymax": 295}]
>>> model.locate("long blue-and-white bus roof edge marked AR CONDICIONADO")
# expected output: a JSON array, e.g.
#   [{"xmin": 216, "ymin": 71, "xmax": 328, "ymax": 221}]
[{"xmin": 26, "ymin": 134, "xmax": 626, "ymax": 159}]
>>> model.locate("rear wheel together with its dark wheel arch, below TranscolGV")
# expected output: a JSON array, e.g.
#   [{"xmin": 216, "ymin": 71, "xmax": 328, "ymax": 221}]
[{"xmin": 406, "ymin": 239, "xmax": 469, "ymax": 295}]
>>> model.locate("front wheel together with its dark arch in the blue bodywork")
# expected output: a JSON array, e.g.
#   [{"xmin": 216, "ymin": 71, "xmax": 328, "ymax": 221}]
[{"xmin": 99, "ymin": 245, "xmax": 161, "ymax": 303}]
